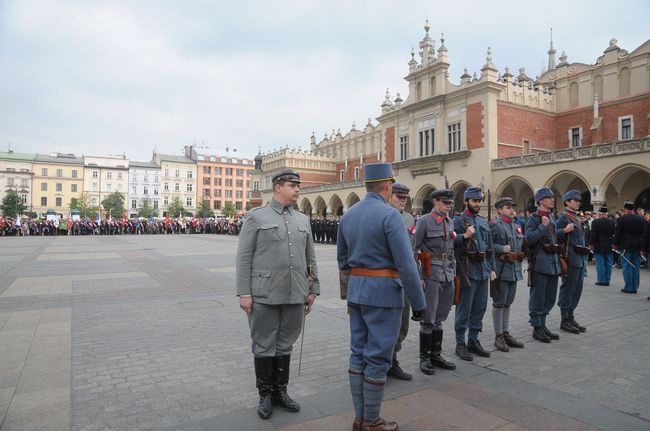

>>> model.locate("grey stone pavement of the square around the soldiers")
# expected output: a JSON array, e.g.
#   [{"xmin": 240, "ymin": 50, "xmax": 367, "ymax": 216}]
[{"xmin": 0, "ymin": 235, "xmax": 650, "ymax": 431}]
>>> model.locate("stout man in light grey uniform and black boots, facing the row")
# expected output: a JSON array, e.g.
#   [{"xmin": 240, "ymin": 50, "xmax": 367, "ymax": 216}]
[{"xmin": 236, "ymin": 170, "xmax": 320, "ymax": 419}]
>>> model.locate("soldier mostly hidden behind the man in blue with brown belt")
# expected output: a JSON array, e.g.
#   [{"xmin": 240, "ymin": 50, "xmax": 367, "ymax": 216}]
[{"xmin": 388, "ymin": 182, "xmax": 415, "ymax": 380}]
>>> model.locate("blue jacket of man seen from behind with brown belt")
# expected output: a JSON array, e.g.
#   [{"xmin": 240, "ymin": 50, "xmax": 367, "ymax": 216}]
[{"xmin": 336, "ymin": 192, "xmax": 426, "ymax": 311}]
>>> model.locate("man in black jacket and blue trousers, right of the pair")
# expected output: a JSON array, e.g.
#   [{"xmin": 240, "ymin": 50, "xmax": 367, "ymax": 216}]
[{"xmin": 613, "ymin": 201, "xmax": 645, "ymax": 293}]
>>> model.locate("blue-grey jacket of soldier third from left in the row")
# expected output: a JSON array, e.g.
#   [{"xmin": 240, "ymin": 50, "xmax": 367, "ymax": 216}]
[{"xmin": 454, "ymin": 212, "xmax": 496, "ymax": 281}]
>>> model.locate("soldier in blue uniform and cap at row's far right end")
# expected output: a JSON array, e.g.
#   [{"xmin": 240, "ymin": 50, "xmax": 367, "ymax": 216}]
[{"xmin": 557, "ymin": 190, "xmax": 589, "ymax": 334}]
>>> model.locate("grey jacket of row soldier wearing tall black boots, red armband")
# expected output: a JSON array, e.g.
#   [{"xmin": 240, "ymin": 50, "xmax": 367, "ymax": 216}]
[{"xmin": 415, "ymin": 213, "xmax": 456, "ymax": 282}]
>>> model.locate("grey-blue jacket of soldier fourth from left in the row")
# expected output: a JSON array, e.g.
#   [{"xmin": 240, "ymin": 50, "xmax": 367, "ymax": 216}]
[{"xmin": 490, "ymin": 218, "xmax": 524, "ymax": 281}]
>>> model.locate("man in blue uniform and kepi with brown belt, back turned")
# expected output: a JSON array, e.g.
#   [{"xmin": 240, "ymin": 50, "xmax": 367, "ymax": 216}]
[{"xmin": 337, "ymin": 163, "xmax": 426, "ymax": 431}]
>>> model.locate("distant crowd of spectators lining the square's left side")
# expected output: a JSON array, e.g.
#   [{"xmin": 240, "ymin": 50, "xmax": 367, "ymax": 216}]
[{"xmin": 0, "ymin": 217, "xmax": 243, "ymax": 236}]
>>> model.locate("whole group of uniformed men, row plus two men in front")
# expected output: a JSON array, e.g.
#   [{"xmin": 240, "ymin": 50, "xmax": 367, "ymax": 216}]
[{"xmin": 237, "ymin": 163, "xmax": 650, "ymax": 431}]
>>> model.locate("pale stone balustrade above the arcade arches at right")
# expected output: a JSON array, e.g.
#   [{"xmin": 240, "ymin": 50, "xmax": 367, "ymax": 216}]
[{"xmin": 492, "ymin": 138, "xmax": 650, "ymax": 170}]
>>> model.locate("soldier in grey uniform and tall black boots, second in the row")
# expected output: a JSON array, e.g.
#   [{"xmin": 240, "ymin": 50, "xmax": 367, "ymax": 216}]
[{"xmin": 415, "ymin": 189, "xmax": 456, "ymax": 375}]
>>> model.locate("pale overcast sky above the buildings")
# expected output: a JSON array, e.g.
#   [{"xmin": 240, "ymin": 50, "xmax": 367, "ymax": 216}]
[{"xmin": 0, "ymin": 0, "xmax": 650, "ymax": 160}]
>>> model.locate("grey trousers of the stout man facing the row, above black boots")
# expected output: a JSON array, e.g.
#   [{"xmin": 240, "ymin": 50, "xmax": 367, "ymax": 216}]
[{"xmin": 248, "ymin": 302, "xmax": 305, "ymax": 356}]
